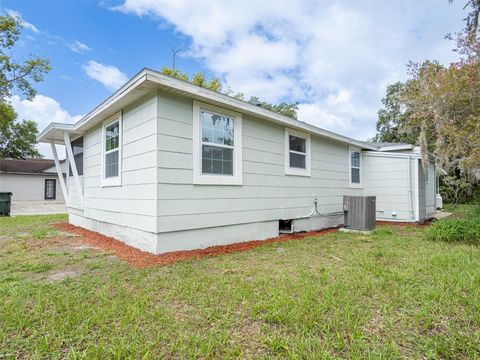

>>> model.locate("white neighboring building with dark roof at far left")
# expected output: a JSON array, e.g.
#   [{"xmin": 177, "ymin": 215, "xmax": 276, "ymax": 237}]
[{"xmin": 0, "ymin": 159, "xmax": 66, "ymax": 215}]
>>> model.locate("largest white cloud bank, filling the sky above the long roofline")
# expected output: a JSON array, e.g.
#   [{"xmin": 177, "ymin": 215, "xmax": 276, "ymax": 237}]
[{"xmin": 115, "ymin": 0, "xmax": 465, "ymax": 139}]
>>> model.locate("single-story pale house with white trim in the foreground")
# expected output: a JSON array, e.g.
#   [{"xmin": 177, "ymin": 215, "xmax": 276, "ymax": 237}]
[{"xmin": 38, "ymin": 69, "xmax": 435, "ymax": 253}]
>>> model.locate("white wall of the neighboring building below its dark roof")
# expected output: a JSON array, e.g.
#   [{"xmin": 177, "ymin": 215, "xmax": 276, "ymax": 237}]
[{"xmin": 0, "ymin": 173, "xmax": 63, "ymax": 201}]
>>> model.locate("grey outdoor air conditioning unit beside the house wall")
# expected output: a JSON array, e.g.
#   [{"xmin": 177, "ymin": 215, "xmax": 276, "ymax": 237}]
[{"xmin": 343, "ymin": 195, "xmax": 376, "ymax": 231}]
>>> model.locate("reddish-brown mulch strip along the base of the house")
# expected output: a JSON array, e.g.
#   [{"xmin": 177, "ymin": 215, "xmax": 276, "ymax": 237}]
[{"xmin": 54, "ymin": 223, "xmax": 338, "ymax": 269}]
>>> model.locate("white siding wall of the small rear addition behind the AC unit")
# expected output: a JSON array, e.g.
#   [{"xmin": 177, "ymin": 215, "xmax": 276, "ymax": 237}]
[{"xmin": 362, "ymin": 154, "xmax": 415, "ymax": 220}]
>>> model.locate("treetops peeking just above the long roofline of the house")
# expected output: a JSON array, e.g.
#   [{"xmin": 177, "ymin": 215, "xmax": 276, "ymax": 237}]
[{"xmin": 160, "ymin": 66, "xmax": 298, "ymax": 119}]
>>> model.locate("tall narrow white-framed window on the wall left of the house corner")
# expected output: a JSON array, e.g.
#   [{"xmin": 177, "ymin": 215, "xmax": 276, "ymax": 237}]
[{"xmin": 102, "ymin": 115, "xmax": 122, "ymax": 186}]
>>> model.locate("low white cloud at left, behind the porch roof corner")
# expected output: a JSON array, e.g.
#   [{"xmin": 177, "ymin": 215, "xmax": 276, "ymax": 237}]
[{"xmin": 10, "ymin": 95, "xmax": 82, "ymax": 158}]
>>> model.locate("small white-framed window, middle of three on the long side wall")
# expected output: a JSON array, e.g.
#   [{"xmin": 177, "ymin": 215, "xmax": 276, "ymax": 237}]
[{"xmin": 285, "ymin": 129, "xmax": 311, "ymax": 176}]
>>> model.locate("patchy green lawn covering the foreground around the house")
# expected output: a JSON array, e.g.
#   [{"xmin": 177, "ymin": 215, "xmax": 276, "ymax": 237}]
[{"xmin": 0, "ymin": 207, "xmax": 480, "ymax": 359}]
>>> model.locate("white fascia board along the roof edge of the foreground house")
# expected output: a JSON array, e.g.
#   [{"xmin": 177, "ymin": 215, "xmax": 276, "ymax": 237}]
[{"xmin": 38, "ymin": 68, "xmax": 378, "ymax": 150}]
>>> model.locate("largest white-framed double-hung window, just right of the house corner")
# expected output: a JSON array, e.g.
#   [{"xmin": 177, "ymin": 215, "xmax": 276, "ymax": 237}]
[{"xmin": 193, "ymin": 102, "xmax": 242, "ymax": 185}]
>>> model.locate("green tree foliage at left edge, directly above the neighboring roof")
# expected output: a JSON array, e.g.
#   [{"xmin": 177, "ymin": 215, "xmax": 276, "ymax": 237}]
[{"xmin": 0, "ymin": 100, "xmax": 42, "ymax": 159}]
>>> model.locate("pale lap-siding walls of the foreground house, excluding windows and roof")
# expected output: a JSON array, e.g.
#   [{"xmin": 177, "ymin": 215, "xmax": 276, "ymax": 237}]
[{"xmin": 62, "ymin": 91, "xmax": 433, "ymax": 253}]
